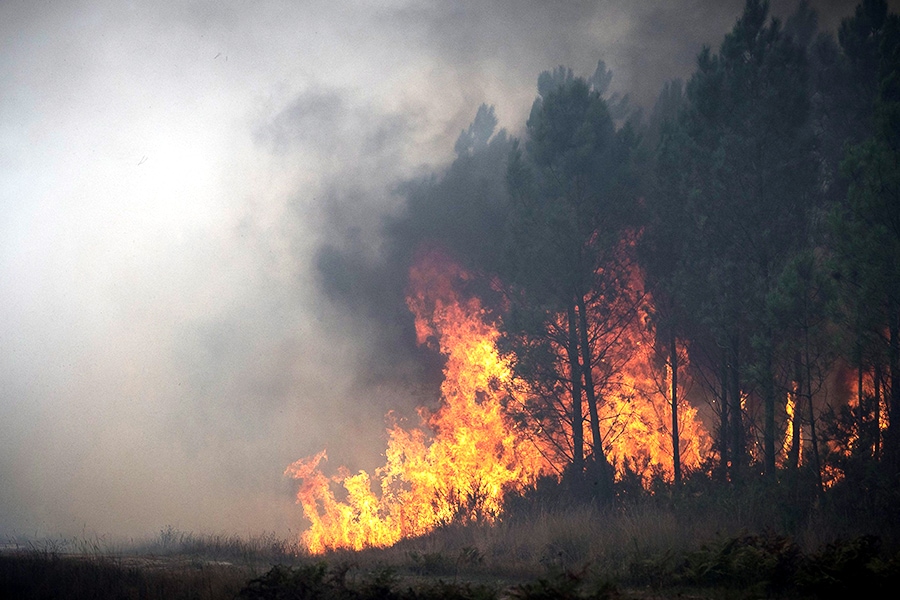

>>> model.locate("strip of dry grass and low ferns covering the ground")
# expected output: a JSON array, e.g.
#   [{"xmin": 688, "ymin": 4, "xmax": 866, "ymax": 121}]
[{"xmin": 7, "ymin": 486, "xmax": 900, "ymax": 600}]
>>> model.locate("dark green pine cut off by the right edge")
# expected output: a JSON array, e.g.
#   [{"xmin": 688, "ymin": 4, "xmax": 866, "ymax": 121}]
[{"xmin": 830, "ymin": 0, "xmax": 900, "ymax": 474}]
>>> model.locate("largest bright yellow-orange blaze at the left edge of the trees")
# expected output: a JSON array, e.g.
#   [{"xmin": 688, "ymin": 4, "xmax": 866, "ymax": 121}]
[{"xmin": 285, "ymin": 254, "xmax": 550, "ymax": 553}]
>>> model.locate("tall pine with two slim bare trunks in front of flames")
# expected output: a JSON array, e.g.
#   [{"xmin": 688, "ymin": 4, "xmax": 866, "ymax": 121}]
[{"xmin": 504, "ymin": 67, "xmax": 636, "ymax": 499}]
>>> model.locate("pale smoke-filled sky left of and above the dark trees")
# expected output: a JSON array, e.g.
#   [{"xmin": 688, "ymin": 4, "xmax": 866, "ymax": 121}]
[{"xmin": 0, "ymin": 0, "xmax": 876, "ymax": 543}]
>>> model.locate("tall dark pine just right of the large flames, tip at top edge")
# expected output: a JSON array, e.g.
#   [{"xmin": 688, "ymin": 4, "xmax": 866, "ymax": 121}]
[{"xmin": 685, "ymin": 0, "xmax": 815, "ymax": 475}]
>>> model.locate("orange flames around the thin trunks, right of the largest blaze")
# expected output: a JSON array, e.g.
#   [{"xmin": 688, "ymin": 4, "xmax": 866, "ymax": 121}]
[{"xmin": 500, "ymin": 234, "xmax": 712, "ymax": 487}]
